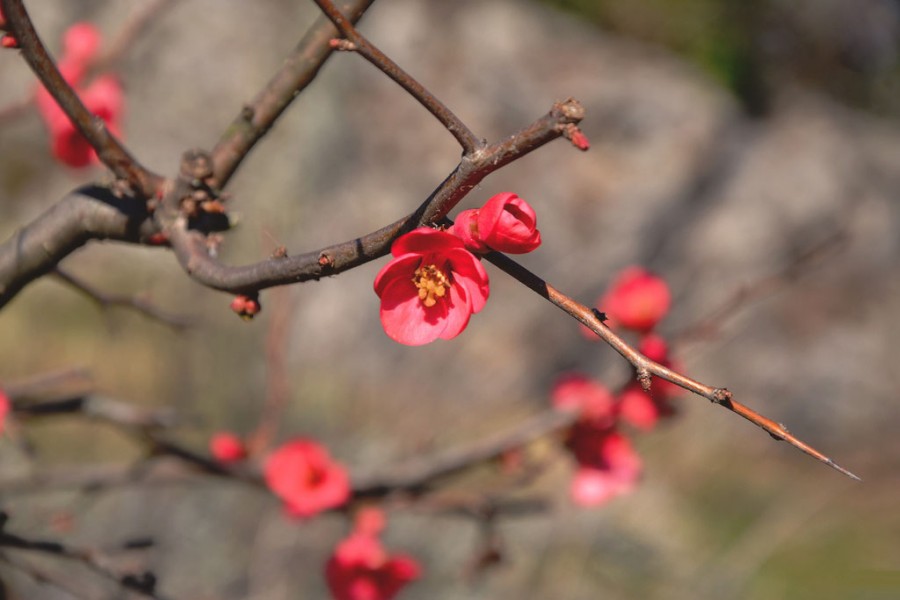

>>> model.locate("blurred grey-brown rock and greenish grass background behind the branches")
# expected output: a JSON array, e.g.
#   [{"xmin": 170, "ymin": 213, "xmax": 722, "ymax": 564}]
[{"xmin": 0, "ymin": 0, "xmax": 900, "ymax": 600}]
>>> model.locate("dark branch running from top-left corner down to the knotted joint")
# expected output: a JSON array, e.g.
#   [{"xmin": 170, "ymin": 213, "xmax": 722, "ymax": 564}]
[{"xmin": 0, "ymin": 0, "xmax": 162, "ymax": 198}]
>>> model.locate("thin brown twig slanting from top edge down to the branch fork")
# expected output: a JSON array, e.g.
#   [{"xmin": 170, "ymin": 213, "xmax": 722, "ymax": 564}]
[{"xmin": 314, "ymin": 0, "xmax": 482, "ymax": 154}]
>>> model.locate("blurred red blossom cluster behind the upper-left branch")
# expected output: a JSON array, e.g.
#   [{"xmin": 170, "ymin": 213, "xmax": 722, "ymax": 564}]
[{"xmin": 35, "ymin": 23, "xmax": 124, "ymax": 168}]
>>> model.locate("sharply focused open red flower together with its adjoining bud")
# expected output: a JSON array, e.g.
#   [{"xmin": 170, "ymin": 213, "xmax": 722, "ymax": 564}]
[{"xmin": 375, "ymin": 192, "xmax": 541, "ymax": 346}]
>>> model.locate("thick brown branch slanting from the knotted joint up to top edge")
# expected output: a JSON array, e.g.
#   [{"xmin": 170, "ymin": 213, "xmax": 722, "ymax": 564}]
[{"xmin": 212, "ymin": 0, "xmax": 375, "ymax": 189}]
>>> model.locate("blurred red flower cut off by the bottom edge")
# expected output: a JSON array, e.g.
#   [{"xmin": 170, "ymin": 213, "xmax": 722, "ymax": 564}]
[{"xmin": 325, "ymin": 509, "xmax": 421, "ymax": 600}]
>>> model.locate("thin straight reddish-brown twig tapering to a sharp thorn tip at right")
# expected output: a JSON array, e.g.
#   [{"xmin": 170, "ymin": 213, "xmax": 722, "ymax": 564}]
[{"xmin": 485, "ymin": 252, "xmax": 860, "ymax": 481}]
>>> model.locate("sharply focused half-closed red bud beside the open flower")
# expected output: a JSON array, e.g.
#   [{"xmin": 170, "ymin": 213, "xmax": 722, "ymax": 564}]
[{"xmin": 451, "ymin": 192, "xmax": 541, "ymax": 254}]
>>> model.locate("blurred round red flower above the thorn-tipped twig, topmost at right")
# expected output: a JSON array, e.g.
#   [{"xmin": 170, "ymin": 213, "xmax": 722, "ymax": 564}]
[{"xmin": 598, "ymin": 267, "xmax": 672, "ymax": 332}]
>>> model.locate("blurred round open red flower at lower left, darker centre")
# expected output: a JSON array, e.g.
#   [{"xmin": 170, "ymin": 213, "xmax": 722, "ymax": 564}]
[{"xmin": 264, "ymin": 439, "xmax": 350, "ymax": 517}]
